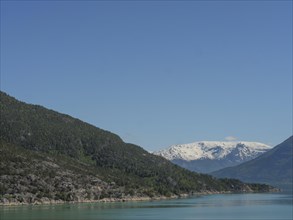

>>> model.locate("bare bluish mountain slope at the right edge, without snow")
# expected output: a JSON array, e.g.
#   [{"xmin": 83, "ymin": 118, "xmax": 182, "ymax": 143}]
[{"xmin": 212, "ymin": 136, "xmax": 293, "ymax": 190}]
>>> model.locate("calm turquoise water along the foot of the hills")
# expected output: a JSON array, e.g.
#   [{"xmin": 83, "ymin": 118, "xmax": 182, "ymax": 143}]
[{"xmin": 0, "ymin": 193, "xmax": 293, "ymax": 220}]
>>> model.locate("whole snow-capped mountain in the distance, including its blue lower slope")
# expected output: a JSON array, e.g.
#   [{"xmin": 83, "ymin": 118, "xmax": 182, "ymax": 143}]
[{"xmin": 154, "ymin": 141, "xmax": 271, "ymax": 173}]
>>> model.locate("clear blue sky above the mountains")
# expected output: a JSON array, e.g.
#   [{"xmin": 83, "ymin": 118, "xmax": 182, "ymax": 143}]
[{"xmin": 1, "ymin": 0, "xmax": 292, "ymax": 151}]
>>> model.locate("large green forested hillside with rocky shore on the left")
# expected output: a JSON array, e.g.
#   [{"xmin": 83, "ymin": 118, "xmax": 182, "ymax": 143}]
[{"xmin": 0, "ymin": 92, "xmax": 271, "ymax": 204}]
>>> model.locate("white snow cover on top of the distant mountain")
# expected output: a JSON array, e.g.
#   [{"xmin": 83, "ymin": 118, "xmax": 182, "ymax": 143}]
[{"xmin": 154, "ymin": 141, "xmax": 271, "ymax": 161}]
